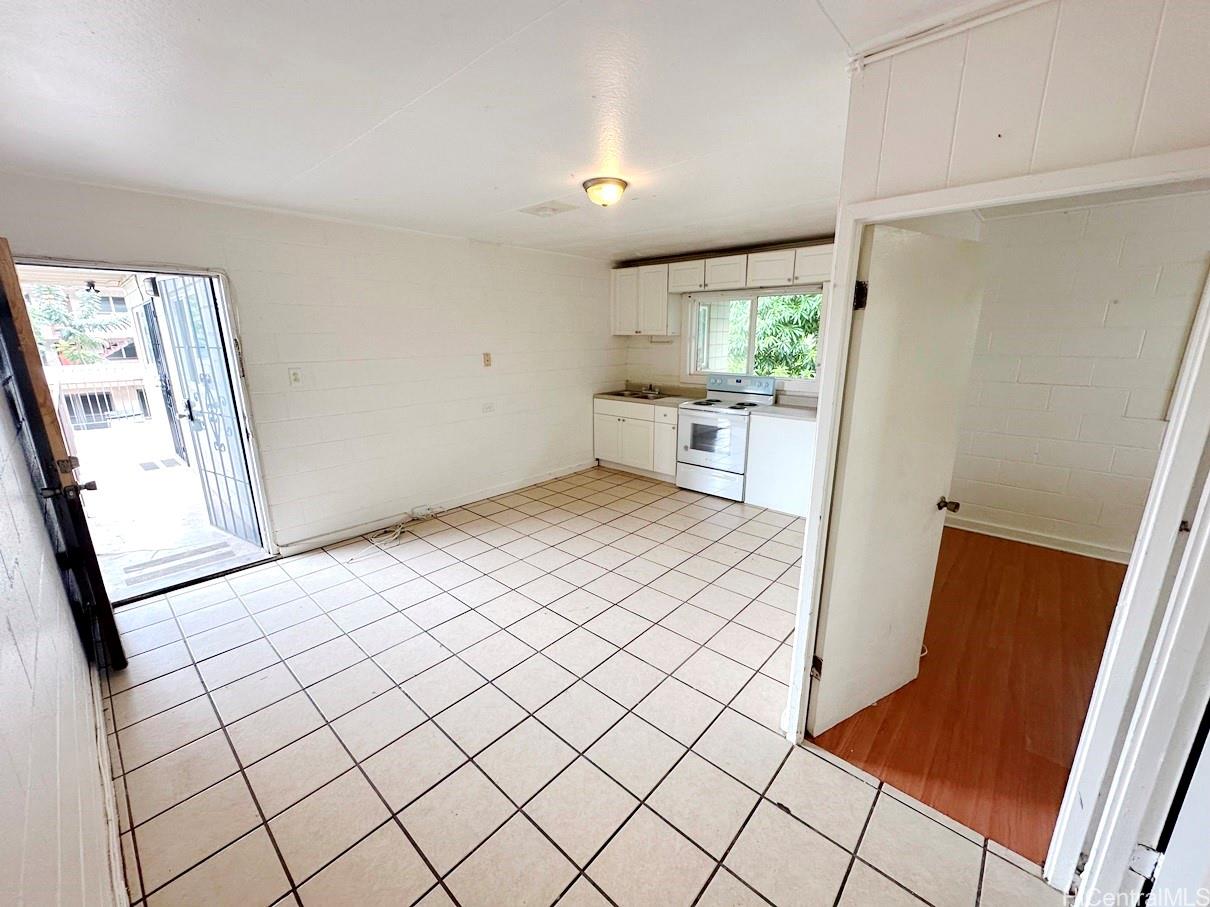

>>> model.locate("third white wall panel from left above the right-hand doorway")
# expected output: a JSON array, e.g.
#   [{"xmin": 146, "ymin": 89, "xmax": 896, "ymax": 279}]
[{"xmin": 950, "ymin": 4, "xmax": 1059, "ymax": 184}]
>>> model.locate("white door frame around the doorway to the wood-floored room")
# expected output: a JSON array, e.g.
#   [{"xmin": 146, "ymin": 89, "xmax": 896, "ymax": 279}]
[{"xmin": 784, "ymin": 148, "xmax": 1210, "ymax": 889}]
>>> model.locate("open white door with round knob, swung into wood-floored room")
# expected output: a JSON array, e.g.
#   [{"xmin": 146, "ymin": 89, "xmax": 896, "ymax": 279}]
[{"xmin": 807, "ymin": 226, "xmax": 984, "ymax": 734}]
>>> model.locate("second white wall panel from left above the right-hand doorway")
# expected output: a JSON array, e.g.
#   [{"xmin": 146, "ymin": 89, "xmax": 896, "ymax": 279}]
[{"xmin": 877, "ymin": 34, "xmax": 967, "ymax": 196}]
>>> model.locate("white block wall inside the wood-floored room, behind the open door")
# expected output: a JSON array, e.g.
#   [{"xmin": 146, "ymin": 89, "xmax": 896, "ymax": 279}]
[{"xmin": 951, "ymin": 192, "xmax": 1210, "ymax": 562}]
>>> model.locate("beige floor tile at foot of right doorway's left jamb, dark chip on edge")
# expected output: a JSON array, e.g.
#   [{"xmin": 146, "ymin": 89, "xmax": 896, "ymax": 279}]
[{"xmin": 767, "ymin": 747, "xmax": 877, "ymax": 850}]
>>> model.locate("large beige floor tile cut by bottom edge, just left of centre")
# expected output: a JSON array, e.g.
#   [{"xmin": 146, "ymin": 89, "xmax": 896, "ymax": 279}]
[{"xmin": 446, "ymin": 814, "xmax": 576, "ymax": 907}]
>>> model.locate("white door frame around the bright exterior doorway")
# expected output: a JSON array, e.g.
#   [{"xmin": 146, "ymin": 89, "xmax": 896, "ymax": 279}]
[{"xmin": 12, "ymin": 254, "xmax": 281, "ymax": 558}]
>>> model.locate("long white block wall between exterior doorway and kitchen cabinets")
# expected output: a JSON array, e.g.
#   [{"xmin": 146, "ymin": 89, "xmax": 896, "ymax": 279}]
[{"xmin": 0, "ymin": 173, "xmax": 626, "ymax": 553}]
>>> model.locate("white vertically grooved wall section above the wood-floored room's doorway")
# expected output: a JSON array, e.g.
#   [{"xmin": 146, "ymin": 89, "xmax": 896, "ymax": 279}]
[{"xmin": 841, "ymin": 0, "xmax": 1210, "ymax": 202}]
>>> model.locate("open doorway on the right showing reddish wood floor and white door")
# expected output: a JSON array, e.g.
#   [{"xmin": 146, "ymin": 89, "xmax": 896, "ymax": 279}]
[{"xmin": 808, "ymin": 187, "xmax": 1210, "ymax": 862}]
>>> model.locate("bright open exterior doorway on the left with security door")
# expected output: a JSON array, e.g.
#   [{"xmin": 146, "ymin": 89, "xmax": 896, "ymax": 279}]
[{"xmin": 17, "ymin": 264, "xmax": 269, "ymax": 603}]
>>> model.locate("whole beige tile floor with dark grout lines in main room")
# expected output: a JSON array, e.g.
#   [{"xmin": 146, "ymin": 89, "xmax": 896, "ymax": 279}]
[{"xmin": 105, "ymin": 469, "xmax": 1062, "ymax": 907}]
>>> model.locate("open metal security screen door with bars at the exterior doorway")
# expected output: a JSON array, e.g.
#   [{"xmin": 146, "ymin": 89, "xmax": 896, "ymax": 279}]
[{"xmin": 155, "ymin": 276, "xmax": 261, "ymax": 545}]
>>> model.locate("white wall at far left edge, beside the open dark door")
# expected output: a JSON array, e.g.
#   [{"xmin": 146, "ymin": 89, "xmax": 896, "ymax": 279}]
[{"xmin": 0, "ymin": 394, "xmax": 117, "ymax": 905}]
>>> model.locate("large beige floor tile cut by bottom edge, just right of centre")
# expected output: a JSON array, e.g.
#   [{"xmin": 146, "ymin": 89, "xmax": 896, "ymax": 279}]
[{"xmin": 588, "ymin": 807, "xmax": 714, "ymax": 907}]
